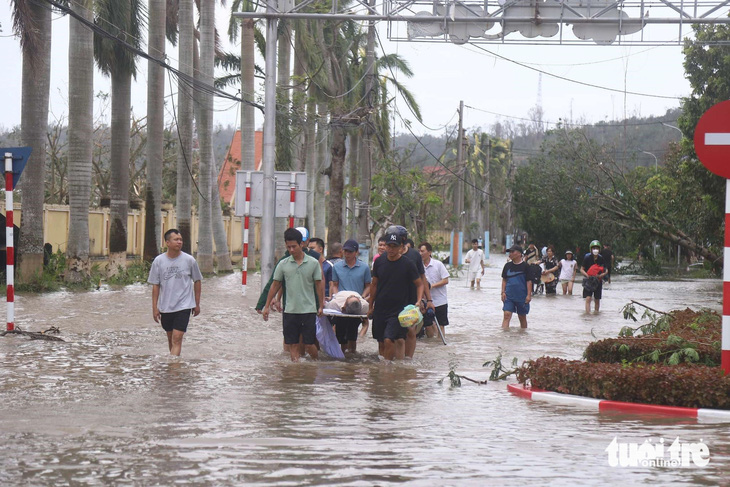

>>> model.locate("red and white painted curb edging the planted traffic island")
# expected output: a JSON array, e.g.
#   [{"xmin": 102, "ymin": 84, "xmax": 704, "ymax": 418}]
[{"xmin": 507, "ymin": 384, "xmax": 730, "ymax": 422}]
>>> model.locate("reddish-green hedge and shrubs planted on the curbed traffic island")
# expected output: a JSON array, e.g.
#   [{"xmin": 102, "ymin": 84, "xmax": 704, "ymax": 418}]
[{"xmin": 517, "ymin": 303, "xmax": 730, "ymax": 409}]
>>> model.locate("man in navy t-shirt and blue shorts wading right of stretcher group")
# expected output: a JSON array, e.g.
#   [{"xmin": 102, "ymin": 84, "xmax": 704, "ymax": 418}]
[{"xmin": 502, "ymin": 245, "xmax": 532, "ymax": 330}]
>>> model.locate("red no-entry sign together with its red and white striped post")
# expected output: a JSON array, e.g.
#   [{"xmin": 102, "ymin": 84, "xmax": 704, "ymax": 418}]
[{"xmin": 694, "ymin": 101, "xmax": 730, "ymax": 375}]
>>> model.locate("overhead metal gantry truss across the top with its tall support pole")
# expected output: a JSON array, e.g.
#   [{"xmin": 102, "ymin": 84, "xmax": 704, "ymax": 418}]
[{"xmin": 231, "ymin": 0, "xmax": 730, "ymax": 287}]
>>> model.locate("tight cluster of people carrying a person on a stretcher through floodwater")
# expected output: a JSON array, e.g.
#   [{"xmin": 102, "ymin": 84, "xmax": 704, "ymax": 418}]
[{"xmin": 256, "ymin": 225, "xmax": 449, "ymax": 360}]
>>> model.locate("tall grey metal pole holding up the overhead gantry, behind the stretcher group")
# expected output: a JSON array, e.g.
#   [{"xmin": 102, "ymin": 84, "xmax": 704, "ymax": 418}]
[{"xmin": 261, "ymin": 0, "xmax": 278, "ymax": 289}]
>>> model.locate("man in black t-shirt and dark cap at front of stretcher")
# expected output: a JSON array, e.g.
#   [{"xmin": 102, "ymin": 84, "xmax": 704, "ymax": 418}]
[{"xmin": 368, "ymin": 233, "xmax": 423, "ymax": 360}]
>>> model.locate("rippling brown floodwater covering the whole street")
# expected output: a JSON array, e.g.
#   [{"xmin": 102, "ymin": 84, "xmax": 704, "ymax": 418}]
[{"xmin": 0, "ymin": 264, "xmax": 730, "ymax": 486}]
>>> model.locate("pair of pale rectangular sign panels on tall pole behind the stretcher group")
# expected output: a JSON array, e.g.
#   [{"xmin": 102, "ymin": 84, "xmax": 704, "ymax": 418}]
[{"xmin": 235, "ymin": 171, "xmax": 307, "ymax": 218}]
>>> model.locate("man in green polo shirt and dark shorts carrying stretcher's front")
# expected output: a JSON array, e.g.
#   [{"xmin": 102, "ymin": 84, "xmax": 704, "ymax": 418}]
[{"xmin": 262, "ymin": 228, "xmax": 324, "ymax": 362}]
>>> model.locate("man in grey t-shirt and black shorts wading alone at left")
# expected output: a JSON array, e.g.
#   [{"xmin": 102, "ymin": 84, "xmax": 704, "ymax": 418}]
[{"xmin": 147, "ymin": 228, "xmax": 203, "ymax": 355}]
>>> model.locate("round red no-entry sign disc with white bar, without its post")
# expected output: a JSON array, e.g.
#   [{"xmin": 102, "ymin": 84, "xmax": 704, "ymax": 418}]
[{"xmin": 694, "ymin": 101, "xmax": 730, "ymax": 179}]
